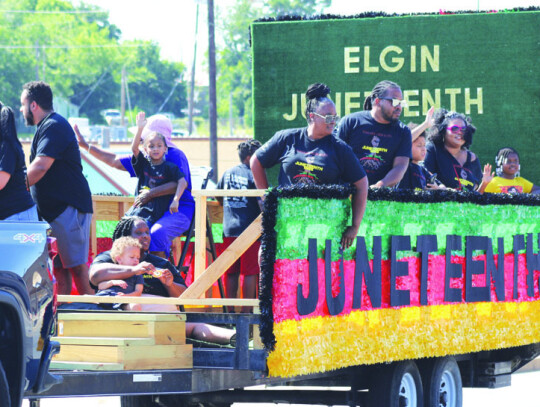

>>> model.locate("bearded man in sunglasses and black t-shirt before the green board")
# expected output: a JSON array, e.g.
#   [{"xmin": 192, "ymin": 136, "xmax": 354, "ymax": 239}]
[{"xmin": 337, "ymin": 81, "xmax": 411, "ymax": 188}]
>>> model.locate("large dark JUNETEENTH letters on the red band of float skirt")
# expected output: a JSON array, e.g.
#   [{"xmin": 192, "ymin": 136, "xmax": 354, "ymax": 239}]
[{"xmin": 296, "ymin": 234, "xmax": 540, "ymax": 316}]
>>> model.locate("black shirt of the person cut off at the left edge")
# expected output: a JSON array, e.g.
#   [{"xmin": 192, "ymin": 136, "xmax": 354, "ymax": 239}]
[{"xmin": 0, "ymin": 140, "xmax": 34, "ymax": 220}]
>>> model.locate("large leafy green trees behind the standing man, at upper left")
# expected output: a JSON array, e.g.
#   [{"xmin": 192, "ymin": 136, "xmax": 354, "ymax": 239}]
[{"xmin": 0, "ymin": 0, "xmax": 187, "ymax": 123}]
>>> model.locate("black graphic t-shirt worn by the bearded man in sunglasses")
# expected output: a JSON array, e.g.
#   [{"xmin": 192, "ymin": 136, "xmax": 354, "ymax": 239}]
[{"xmin": 336, "ymin": 111, "xmax": 412, "ymax": 185}]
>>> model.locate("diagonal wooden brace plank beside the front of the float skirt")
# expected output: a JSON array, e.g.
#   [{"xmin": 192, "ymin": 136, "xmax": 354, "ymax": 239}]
[{"xmin": 180, "ymin": 214, "xmax": 262, "ymax": 299}]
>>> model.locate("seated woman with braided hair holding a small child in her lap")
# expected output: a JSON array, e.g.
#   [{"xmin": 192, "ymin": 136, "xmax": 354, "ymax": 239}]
[{"xmin": 89, "ymin": 216, "xmax": 235, "ymax": 344}]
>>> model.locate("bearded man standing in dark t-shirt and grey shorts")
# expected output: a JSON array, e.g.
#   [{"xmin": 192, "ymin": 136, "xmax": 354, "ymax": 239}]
[{"xmin": 21, "ymin": 81, "xmax": 94, "ymax": 294}]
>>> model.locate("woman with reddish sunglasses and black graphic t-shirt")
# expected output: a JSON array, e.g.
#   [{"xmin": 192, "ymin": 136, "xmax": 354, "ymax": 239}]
[{"xmin": 424, "ymin": 109, "xmax": 482, "ymax": 191}]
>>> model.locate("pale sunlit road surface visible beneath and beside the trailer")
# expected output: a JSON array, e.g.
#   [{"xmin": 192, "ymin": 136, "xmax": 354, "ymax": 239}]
[{"xmin": 23, "ymin": 372, "xmax": 540, "ymax": 407}]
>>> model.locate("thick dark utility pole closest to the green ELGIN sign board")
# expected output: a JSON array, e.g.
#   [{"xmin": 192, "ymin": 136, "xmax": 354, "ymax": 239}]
[{"xmin": 208, "ymin": 0, "xmax": 218, "ymax": 182}]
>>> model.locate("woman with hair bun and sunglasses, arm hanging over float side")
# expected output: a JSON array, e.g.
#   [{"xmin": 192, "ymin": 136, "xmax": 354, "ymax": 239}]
[{"xmin": 250, "ymin": 83, "xmax": 368, "ymax": 248}]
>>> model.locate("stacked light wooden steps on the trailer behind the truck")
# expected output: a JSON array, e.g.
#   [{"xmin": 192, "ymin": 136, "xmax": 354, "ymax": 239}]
[{"xmin": 51, "ymin": 312, "xmax": 193, "ymax": 370}]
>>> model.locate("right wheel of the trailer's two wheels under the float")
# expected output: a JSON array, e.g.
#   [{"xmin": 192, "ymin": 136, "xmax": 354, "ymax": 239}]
[{"xmin": 422, "ymin": 356, "xmax": 463, "ymax": 407}]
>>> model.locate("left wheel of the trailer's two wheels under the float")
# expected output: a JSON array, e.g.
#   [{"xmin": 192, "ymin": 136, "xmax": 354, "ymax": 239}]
[{"xmin": 367, "ymin": 361, "xmax": 424, "ymax": 407}]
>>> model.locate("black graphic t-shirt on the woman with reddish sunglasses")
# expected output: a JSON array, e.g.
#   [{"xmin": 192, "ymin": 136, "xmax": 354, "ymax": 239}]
[{"xmin": 424, "ymin": 142, "xmax": 482, "ymax": 191}]
